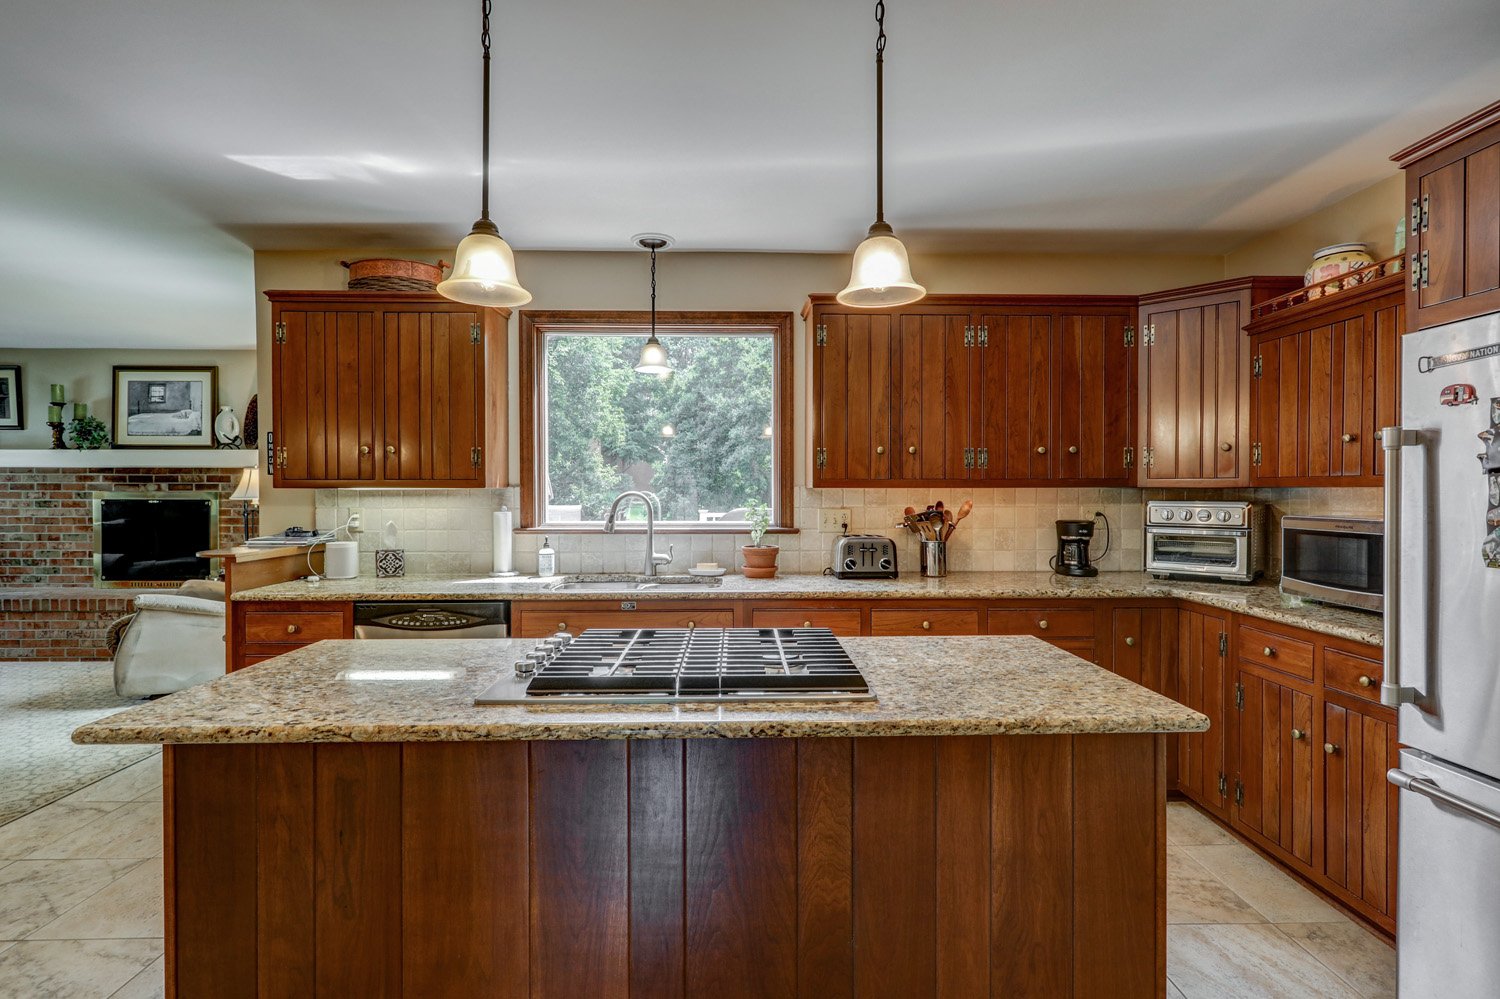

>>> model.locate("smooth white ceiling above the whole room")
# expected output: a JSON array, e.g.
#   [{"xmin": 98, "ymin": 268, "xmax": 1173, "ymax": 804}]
[{"xmin": 0, "ymin": 0, "xmax": 1500, "ymax": 347}]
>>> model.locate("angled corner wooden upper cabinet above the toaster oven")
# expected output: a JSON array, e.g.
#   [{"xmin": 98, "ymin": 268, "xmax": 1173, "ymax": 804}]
[{"xmin": 1139, "ymin": 278, "xmax": 1302, "ymax": 486}]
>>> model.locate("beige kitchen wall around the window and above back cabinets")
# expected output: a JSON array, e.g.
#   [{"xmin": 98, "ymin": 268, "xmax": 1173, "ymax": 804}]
[{"xmin": 255, "ymin": 248, "xmax": 1223, "ymax": 530}]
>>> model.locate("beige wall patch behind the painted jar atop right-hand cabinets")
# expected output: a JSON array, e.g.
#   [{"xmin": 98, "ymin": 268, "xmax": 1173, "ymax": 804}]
[{"xmin": 1224, "ymin": 173, "xmax": 1406, "ymax": 278}]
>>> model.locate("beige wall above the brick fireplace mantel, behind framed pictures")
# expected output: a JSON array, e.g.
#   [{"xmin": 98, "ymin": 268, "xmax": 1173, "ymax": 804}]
[{"xmin": 0, "ymin": 350, "xmax": 257, "ymax": 447}]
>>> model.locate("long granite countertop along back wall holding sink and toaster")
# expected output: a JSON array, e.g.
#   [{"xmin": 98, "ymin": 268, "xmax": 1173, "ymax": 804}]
[{"xmin": 234, "ymin": 573, "xmax": 1382, "ymax": 645}]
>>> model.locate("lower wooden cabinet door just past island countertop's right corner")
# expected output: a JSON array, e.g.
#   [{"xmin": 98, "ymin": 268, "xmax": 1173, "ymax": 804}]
[{"xmin": 1176, "ymin": 609, "xmax": 1229, "ymax": 816}]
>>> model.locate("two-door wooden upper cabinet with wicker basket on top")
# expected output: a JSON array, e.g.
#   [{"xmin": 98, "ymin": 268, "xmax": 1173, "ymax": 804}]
[{"xmin": 266, "ymin": 291, "xmax": 510, "ymax": 488}]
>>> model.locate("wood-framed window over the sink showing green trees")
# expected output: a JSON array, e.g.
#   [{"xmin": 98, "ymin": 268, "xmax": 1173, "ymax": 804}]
[{"xmin": 521, "ymin": 312, "xmax": 792, "ymax": 531}]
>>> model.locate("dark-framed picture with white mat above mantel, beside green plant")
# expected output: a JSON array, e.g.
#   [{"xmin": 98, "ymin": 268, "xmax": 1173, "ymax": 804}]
[{"xmin": 113, "ymin": 365, "xmax": 219, "ymax": 447}]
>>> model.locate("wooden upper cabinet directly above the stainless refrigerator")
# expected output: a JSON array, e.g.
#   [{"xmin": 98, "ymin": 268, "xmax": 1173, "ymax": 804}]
[{"xmin": 1391, "ymin": 101, "xmax": 1500, "ymax": 329}]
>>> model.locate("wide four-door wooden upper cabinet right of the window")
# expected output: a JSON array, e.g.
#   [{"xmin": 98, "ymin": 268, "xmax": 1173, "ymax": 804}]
[{"xmin": 803, "ymin": 296, "xmax": 1136, "ymax": 486}]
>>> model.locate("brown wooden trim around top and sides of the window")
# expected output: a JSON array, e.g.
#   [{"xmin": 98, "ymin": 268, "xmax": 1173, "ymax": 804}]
[{"xmin": 516, "ymin": 311, "xmax": 795, "ymax": 530}]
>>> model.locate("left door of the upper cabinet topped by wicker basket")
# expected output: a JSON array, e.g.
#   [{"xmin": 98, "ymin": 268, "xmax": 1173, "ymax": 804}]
[{"xmin": 272, "ymin": 308, "xmax": 378, "ymax": 488}]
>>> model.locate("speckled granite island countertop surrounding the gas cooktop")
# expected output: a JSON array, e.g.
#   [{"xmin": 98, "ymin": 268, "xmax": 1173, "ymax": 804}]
[{"xmin": 74, "ymin": 636, "xmax": 1208, "ymax": 744}]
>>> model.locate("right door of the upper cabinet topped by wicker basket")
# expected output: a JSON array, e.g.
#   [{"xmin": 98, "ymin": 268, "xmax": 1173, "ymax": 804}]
[{"xmin": 380, "ymin": 309, "xmax": 485, "ymax": 486}]
